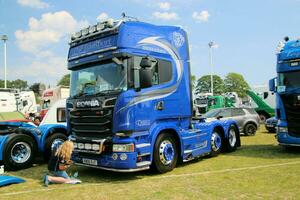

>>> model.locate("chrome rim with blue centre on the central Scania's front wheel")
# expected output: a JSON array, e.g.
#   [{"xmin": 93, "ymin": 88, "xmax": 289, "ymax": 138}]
[{"xmin": 159, "ymin": 140, "xmax": 175, "ymax": 165}]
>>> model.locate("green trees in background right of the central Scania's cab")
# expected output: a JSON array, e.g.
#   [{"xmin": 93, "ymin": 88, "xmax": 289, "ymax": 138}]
[{"xmin": 191, "ymin": 73, "xmax": 250, "ymax": 98}]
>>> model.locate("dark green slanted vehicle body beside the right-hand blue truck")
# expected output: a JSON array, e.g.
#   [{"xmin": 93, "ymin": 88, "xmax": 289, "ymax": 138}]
[{"xmin": 247, "ymin": 90, "xmax": 275, "ymax": 123}]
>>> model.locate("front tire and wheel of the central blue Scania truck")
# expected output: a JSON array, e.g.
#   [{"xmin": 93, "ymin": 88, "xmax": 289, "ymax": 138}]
[{"xmin": 151, "ymin": 133, "xmax": 179, "ymax": 173}]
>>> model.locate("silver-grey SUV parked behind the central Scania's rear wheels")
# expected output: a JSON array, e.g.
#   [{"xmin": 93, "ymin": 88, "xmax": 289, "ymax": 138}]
[{"xmin": 202, "ymin": 108, "xmax": 260, "ymax": 135}]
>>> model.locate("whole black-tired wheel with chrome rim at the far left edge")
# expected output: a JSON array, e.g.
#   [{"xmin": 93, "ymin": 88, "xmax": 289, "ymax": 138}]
[{"xmin": 3, "ymin": 133, "xmax": 37, "ymax": 170}]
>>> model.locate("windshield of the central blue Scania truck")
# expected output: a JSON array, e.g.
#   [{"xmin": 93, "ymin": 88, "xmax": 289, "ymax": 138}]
[{"xmin": 71, "ymin": 62, "xmax": 127, "ymax": 97}]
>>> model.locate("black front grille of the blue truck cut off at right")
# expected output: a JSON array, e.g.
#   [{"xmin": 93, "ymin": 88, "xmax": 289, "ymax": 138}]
[{"xmin": 281, "ymin": 94, "xmax": 300, "ymax": 137}]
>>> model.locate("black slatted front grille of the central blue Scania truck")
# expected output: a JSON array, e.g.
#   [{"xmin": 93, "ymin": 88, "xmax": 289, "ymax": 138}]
[{"xmin": 70, "ymin": 108, "xmax": 113, "ymax": 139}]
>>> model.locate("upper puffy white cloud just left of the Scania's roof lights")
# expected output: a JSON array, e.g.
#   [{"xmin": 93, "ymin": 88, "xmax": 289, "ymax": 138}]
[{"xmin": 15, "ymin": 11, "xmax": 88, "ymax": 53}]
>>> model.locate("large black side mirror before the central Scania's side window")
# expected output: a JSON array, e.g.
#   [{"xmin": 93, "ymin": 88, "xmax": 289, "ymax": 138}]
[{"xmin": 140, "ymin": 57, "xmax": 156, "ymax": 88}]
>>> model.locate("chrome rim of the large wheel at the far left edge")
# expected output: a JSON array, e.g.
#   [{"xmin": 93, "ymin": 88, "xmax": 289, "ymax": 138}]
[{"xmin": 10, "ymin": 142, "xmax": 31, "ymax": 163}]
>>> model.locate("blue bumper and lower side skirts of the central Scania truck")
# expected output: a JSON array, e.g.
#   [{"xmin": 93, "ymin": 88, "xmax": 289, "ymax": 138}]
[{"xmin": 71, "ymin": 120, "xmax": 240, "ymax": 172}]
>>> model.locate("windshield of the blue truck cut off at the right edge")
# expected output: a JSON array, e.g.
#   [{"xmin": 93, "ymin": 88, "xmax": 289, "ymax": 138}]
[{"xmin": 278, "ymin": 71, "xmax": 300, "ymax": 88}]
